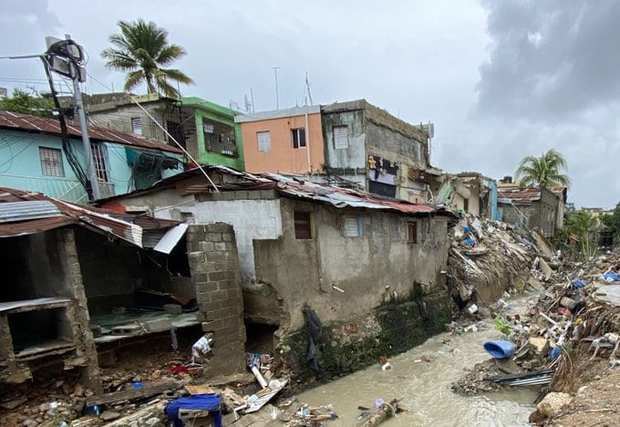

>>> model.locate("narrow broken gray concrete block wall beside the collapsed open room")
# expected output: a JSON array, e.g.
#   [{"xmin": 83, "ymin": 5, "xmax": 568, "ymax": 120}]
[{"xmin": 187, "ymin": 223, "xmax": 245, "ymax": 376}]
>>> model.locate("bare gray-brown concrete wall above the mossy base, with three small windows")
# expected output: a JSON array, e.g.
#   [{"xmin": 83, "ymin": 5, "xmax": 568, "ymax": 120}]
[{"xmin": 254, "ymin": 199, "xmax": 449, "ymax": 330}]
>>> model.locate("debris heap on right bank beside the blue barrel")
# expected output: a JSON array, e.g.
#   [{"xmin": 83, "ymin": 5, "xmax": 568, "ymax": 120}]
[{"xmin": 453, "ymin": 247, "xmax": 620, "ymax": 423}]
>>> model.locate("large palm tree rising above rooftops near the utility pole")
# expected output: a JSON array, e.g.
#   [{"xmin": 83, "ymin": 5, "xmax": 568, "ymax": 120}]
[{"xmin": 101, "ymin": 19, "xmax": 193, "ymax": 98}]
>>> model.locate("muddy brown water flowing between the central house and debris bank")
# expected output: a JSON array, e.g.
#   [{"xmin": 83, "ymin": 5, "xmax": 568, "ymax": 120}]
[{"xmin": 298, "ymin": 298, "xmax": 537, "ymax": 427}]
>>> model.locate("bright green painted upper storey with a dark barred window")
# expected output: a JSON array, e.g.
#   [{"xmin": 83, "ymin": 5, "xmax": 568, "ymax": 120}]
[{"xmin": 181, "ymin": 96, "xmax": 245, "ymax": 170}]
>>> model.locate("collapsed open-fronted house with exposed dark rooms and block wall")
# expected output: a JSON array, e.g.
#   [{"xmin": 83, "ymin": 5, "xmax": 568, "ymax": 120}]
[{"xmin": 0, "ymin": 188, "xmax": 245, "ymax": 391}]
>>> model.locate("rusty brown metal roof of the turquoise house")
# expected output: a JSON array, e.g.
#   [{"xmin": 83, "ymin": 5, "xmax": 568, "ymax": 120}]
[{"xmin": 0, "ymin": 111, "xmax": 183, "ymax": 154}]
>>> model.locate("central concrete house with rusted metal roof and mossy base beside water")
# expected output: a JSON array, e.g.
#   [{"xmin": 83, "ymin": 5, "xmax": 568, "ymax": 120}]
[{"xmin": 101, "ymin": 167, "xmax": 452, "ymax": 378}]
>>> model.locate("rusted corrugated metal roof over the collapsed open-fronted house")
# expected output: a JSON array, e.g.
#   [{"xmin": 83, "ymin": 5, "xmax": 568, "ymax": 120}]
[{"xmin": 0, "ymin": 187, "xmax": 179, "ymax": 247}]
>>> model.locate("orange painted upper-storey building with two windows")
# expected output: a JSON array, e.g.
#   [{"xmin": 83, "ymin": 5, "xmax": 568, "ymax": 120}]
[{"xmin": 235, "ymin": 105, "xmax": 325, "ymax": 174}]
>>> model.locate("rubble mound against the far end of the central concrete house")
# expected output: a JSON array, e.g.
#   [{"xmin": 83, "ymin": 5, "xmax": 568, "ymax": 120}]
[{"xmin": 448, "ymin": 216, "xmax": 540, "ymax": 311}]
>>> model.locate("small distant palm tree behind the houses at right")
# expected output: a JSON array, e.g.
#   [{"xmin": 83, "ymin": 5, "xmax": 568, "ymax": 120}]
[{"xmin": 515, "ymin": 149, "xmax": 570, "ymax": 188}]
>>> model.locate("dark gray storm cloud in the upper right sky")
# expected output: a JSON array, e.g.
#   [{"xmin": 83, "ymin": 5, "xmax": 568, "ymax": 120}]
[{"xmin": 478, "ymin": 0, "xmax": 620, "ymax": 121}]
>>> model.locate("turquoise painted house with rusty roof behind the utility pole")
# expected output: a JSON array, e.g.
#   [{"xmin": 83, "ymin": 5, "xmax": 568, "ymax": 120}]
[{"xmin": 0, "ymin": 111, "xmax": 185, "ymax": 203}]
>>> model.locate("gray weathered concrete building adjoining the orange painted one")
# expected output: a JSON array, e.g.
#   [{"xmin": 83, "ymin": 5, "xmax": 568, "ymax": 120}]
[{"xmin": 321, "ymin": 99, "xmax": 441, "ymax": 203}]
